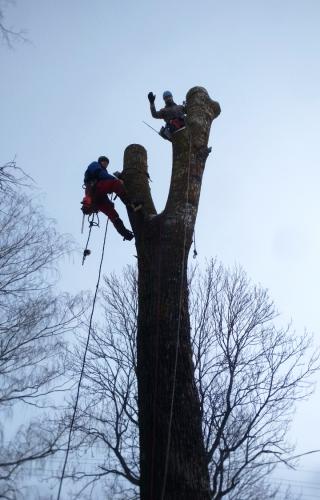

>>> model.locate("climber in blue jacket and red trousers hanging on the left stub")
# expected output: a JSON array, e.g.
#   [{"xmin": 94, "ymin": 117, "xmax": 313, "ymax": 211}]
[{"xmin": 81, "ymin": 156, "xmax": 141, "ymax": 241}]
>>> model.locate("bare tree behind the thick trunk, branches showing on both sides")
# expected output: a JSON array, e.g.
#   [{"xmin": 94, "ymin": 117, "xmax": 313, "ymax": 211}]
[{"xmin": 60, "ymin": 261, "xmax": 318, "ymax": 500}]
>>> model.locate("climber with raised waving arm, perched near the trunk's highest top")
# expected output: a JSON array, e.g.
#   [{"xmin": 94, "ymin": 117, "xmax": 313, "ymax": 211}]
[{"xmin": 148, "ymin": 90, "xmax": 186, "ymax": 141}]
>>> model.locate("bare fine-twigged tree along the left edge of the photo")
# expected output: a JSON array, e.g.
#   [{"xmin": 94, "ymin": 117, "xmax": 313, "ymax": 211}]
[{"xmin": 0, "ymin": 164, "xmax": 83, "ymax": 499}]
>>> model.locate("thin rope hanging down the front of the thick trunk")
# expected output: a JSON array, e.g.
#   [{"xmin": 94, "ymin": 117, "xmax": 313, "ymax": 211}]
[{"xmin": 160, "ymin": 135, "xmax": 192, "ymax": 500}]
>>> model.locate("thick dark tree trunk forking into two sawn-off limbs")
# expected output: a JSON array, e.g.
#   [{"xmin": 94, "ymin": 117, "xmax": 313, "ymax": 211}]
[{"xmin": 124, "ymin": 87, "xmax": 220, "ymax": 500}]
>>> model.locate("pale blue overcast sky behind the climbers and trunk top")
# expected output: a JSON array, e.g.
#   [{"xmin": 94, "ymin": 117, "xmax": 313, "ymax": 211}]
[{"xmin": 0, "ymin": 0, "xmax": 320, "ymax": 499}]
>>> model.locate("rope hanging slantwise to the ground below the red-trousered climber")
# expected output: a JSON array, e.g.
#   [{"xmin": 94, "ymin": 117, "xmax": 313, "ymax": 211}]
[{"xmin": 57, "ymin": 219, "xmax": 109, "ymax": 500}]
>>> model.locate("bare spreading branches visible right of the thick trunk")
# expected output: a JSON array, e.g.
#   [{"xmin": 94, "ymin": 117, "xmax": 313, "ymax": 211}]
[{"xmin": 192, "ymin": 262, "xmax": 319, "ymax": 500}]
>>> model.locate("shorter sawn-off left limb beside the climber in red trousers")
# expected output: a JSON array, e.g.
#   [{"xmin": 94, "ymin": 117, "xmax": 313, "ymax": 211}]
[{"xmin": 123, "ymin": 144, "xmax": 156, "ymax": 215}]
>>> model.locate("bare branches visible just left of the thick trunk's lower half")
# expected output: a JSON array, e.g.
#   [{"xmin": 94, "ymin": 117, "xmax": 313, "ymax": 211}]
[{"xmin": 57, "ymin": 267, "xmax": 139, "ymax": 500}]
